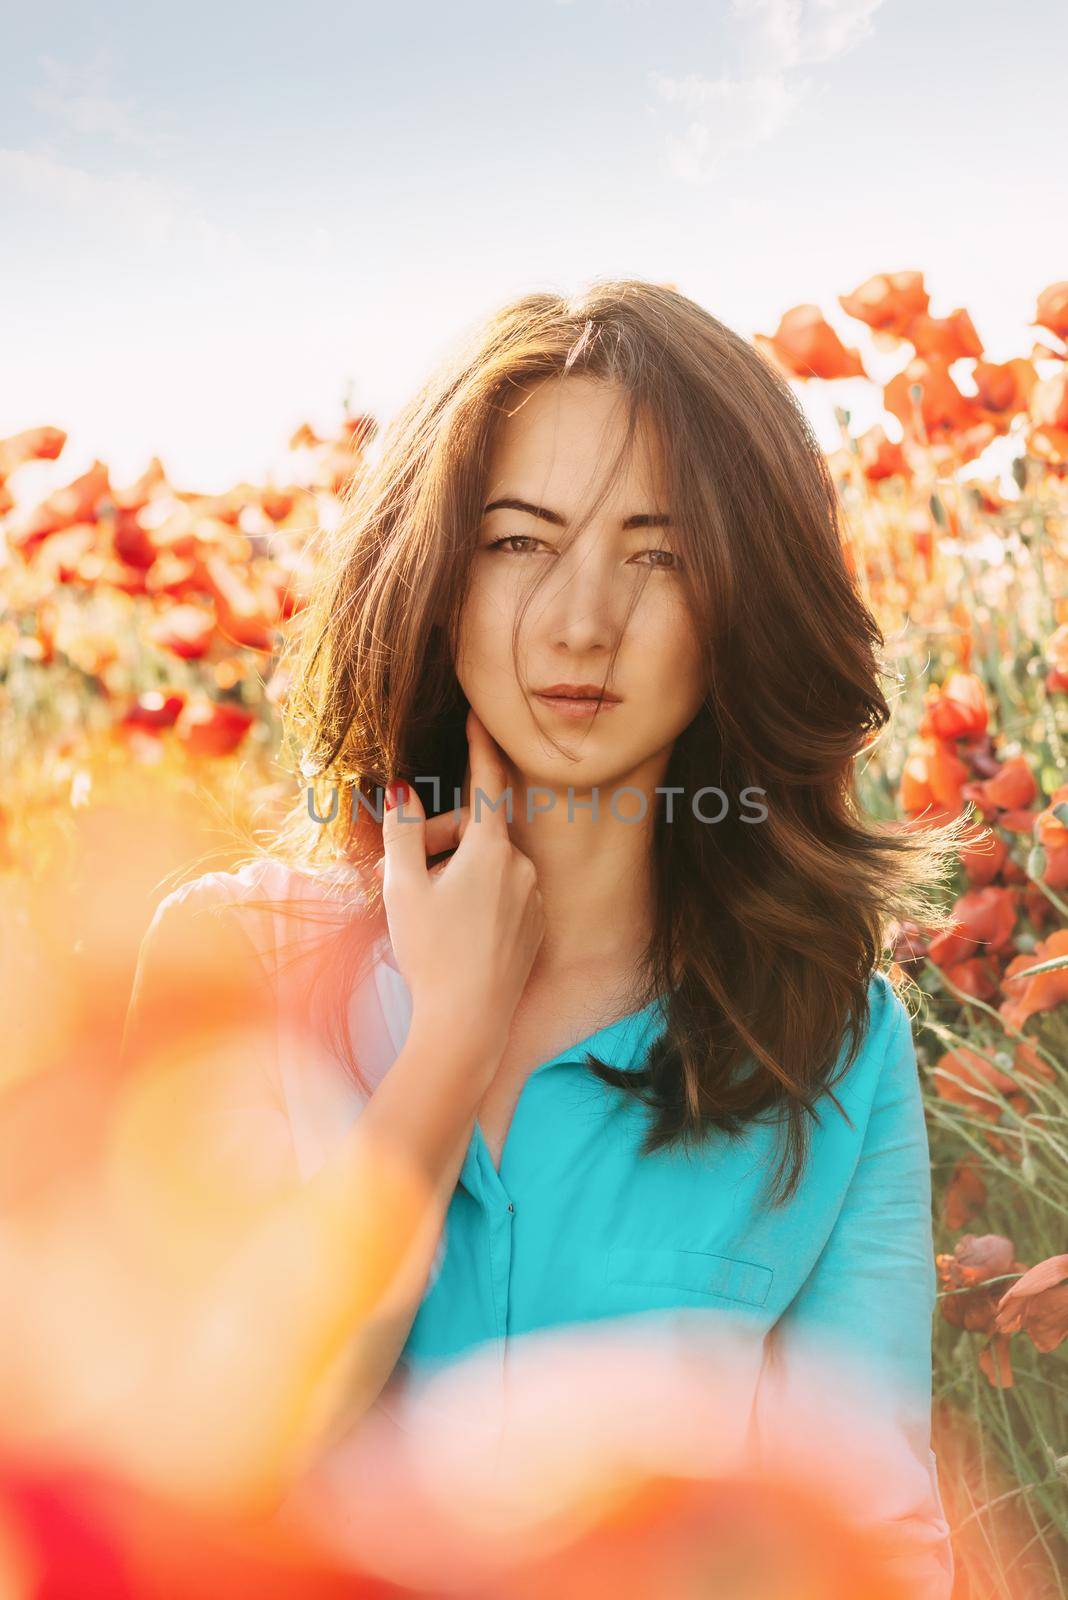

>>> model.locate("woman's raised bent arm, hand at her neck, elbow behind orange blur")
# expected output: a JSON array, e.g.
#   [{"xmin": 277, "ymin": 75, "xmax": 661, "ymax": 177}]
[{"xmin": 119, "ymin": 710, "xmax": 545, "ymax": 1506}]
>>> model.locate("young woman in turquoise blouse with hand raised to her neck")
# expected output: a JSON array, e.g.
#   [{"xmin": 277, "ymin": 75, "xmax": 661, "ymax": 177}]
[{"xmin": 120, "ymin": 280, "xmax": 958, "ymax": 1594}]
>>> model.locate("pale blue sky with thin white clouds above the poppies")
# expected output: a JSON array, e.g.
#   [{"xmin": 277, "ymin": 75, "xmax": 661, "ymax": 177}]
[{"xmin": 0, "ymin": 0, "xmax": 1068, "ymax": 499}]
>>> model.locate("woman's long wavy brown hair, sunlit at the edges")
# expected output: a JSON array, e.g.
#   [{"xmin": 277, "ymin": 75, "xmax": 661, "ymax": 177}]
[{"xmin": 235, "ymin": 280, "xmax": 966, "ymax": 1198}]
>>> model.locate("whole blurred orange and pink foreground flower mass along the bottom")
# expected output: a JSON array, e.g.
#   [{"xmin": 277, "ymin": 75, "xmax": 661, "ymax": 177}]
[{"xmin": 0, "ymin": 811, "xmax": 943, "ymax": 1600}]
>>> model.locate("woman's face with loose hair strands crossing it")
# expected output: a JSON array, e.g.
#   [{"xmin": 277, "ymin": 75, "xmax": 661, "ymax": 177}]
[{"xmin": 456, "ymin": 378, "xmax": 703, "ymax": 811}]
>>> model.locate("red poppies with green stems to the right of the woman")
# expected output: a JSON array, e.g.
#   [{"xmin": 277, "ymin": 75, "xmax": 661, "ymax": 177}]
[{"xmin": 758, "ymin": 274, "xmax": 1068, "ymax": 1594}]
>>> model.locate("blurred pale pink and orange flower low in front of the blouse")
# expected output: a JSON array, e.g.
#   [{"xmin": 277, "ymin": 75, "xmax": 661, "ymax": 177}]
[{"xmin": 283, "ymin": 1314, "xmax": 931, "ymax": 1600}]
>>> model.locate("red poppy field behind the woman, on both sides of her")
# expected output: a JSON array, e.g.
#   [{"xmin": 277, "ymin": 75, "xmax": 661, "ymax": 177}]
[{"xmin": 0, "ymin": 272, "xmax": 1068, "ymax": 1597}]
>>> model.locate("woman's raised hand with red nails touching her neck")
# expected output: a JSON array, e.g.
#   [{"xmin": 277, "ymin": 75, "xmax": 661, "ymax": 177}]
[{"xmin": 382, "ymin": 710, "xmax": 545, "ymax": 1075}]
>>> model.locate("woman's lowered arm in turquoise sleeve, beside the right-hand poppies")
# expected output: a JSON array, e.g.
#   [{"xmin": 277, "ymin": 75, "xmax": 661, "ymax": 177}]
[{"xmin": 758, "ymin": 984, "xmax": 953, "ymax": 1600}]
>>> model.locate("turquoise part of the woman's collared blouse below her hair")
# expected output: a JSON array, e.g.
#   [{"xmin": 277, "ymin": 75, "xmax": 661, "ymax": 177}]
[{"xmin": 401, "ymin": 973, "xmax": 935, "ymax": 1413}]
